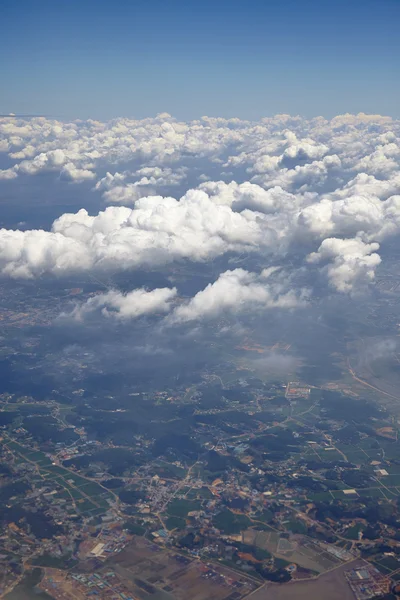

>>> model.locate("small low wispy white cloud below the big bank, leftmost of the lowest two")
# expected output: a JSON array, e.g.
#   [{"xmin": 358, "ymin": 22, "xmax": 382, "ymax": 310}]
[{"xmin": 69, "ymin": 288, "xmax": 177, "ymax": 321}]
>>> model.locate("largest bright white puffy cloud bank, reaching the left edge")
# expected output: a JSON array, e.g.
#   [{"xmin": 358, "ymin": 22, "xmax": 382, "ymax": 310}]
[{"xmin": 0, "ymin": 190, "xmax": 271, "ymax": 277}]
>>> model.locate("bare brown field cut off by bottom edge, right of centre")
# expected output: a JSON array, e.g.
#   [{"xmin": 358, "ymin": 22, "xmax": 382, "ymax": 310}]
[{"xmin": 251, "ymin": 559, "xmax": 365, "ymax": 600}]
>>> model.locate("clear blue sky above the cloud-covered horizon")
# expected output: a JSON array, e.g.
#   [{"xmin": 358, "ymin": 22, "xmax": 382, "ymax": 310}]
[{"xmin": 0, "ymin": 0, "xmax": 400, "ymax": 119}]
